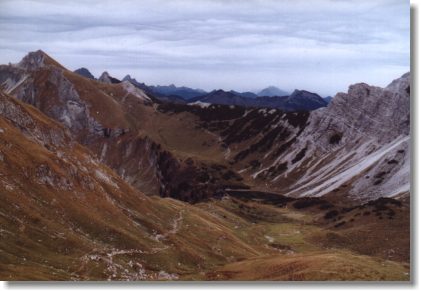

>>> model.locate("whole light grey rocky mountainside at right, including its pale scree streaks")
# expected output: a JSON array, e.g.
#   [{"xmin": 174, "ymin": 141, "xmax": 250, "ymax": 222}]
[{"xmin": 253, "ymin": 74, "xmax": 410, "ymax": 200}]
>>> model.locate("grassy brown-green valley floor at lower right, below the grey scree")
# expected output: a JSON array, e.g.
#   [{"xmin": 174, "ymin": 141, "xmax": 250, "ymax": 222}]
[{"xmin": 193, "ymin": 198, "xmax": 409, "ymax": 281}]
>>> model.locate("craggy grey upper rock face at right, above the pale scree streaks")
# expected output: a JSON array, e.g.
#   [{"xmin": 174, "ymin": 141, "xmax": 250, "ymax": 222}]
[{"xmin": 303, "ymin": 74, "xmax": 410, "ymax": 149}]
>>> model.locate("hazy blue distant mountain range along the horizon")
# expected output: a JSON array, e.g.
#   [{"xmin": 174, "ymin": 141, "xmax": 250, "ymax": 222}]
[{"xmin": 74, "ymin": 68, "xmax": 332, "ymax": 111}]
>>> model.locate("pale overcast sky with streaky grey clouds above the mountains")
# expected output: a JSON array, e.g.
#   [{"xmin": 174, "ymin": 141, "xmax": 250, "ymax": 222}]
[{"xmin": 0, "ymin": 0, "xmax": 410, "ymax": 96}]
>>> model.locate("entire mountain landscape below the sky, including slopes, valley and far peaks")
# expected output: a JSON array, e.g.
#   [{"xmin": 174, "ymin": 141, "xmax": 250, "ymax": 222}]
[{"xmin": 0, "ymin": 50, "xmax": 411, "ymax": 281}]
